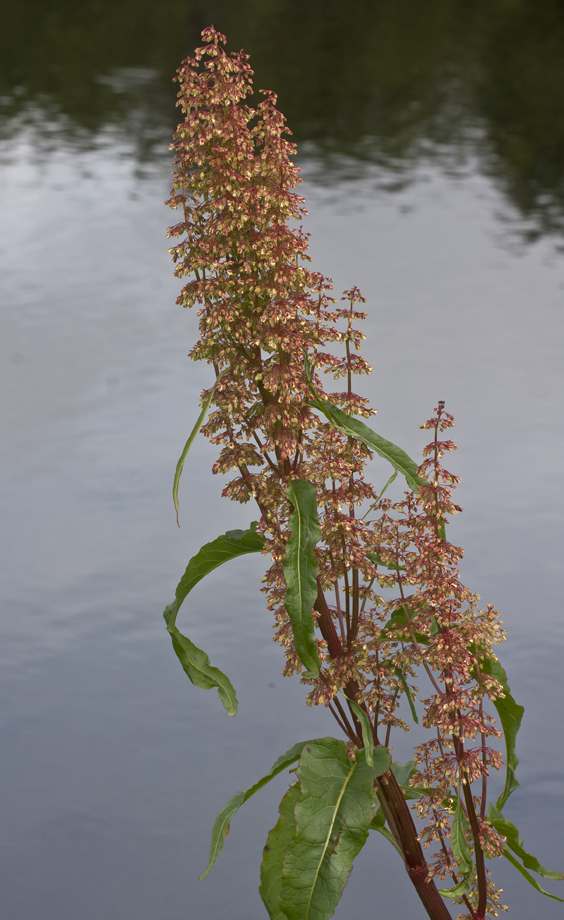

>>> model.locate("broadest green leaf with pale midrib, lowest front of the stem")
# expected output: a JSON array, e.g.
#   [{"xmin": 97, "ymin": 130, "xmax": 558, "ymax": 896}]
[{"xmin": 279, "ymin": 738, "xmax": 375, "ymax": 920}]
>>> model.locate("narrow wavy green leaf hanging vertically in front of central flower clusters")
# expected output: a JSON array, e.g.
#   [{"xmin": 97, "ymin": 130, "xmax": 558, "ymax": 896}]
[{"xmin": 284, "ymin": 479, "xmax": 321, "ymax": 674}]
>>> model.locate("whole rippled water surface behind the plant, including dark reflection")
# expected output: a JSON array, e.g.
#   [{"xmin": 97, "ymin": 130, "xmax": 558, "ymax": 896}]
[{"xmin": 0, "ymin": 0, "xmax": 564, "ymax": 920}]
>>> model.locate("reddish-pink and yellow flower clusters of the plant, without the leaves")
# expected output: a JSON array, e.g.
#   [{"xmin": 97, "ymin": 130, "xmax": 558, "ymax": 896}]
[{"xmin": 169, "ymin": 28, "xmax": 503, "ymax": 917}]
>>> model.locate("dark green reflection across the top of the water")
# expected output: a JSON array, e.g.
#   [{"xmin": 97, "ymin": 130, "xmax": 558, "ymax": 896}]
[{"xmin": 0, "ymin": 0, "xmax": 564, "ymax": 236}]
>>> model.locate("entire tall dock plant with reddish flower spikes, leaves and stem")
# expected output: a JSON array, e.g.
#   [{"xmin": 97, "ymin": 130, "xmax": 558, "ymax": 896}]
[{"xmin": 161, "ymin": 27, "xmax": 564, "ymax": 920}]
